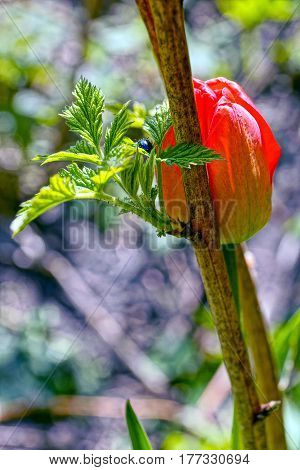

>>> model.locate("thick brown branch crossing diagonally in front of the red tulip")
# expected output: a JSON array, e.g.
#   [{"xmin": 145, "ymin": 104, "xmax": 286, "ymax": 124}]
[{"xmin": 137, "ymin": 0, "xmax": 266, "ymax": 449}]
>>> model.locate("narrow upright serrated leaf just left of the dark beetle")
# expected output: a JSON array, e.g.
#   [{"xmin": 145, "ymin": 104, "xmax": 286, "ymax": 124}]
[{"xmin": 104, "ymin": 101, "xmax": 130, "ymax": 158}]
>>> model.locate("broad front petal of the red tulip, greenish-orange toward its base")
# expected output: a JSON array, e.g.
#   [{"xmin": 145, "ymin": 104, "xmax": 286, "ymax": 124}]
[{"xmin": 206, "ymin": 101, "xmax": 271, "ymax": 243}]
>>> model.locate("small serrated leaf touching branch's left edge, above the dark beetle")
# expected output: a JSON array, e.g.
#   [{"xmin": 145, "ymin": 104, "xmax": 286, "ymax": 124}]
[{"xmin": 144, "ymin": 103, "xmax": 172, "ymax": 147}]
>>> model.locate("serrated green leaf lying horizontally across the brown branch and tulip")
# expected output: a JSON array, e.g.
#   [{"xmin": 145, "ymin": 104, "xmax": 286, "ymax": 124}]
[{"xmin": 157, "ymin": 143, "xmax": 223, "ymax": 169}]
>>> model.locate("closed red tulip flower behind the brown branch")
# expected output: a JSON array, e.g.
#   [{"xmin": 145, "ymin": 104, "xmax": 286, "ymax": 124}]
[{"xmin": 162, "ymin": 78, "xmax": 281, "ymax": 243}]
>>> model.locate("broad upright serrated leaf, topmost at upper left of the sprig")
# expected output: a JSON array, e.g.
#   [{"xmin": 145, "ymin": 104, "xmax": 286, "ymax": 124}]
[{"xmin": 61, "ymin": 77, "xmax": 104, "ymax": 150}]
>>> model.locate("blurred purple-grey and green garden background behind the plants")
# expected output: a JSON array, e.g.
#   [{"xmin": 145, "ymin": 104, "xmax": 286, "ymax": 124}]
[{"xmin": 0, "ymin": 0, "xmax": 300, "ymax": 449}]
